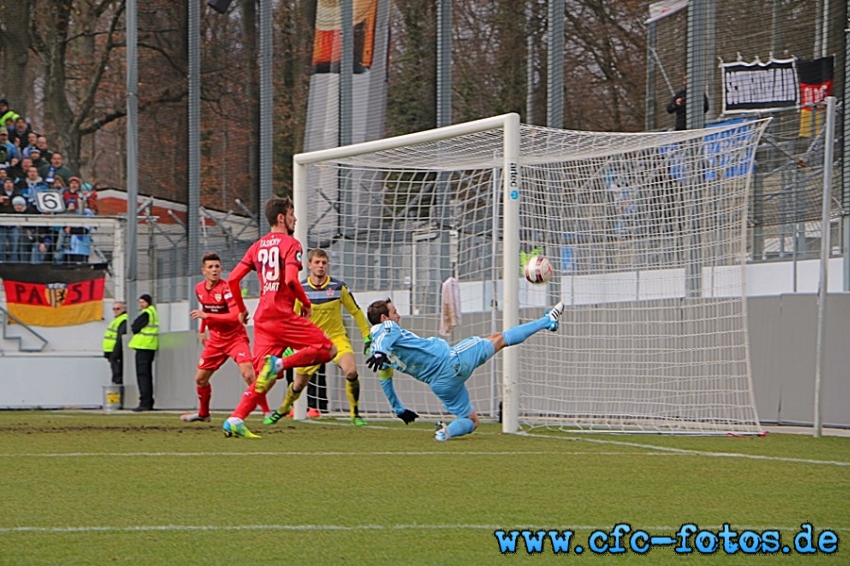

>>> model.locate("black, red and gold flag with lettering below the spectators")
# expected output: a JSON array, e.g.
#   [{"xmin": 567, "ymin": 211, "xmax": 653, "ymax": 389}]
[{"xmin": 0, "ymin": 263, "xmax": 106, "ymax": 326}]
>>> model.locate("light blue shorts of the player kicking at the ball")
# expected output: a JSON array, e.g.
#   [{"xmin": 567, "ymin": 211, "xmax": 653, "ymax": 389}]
[{"xmin": 430, "ymin": 336, "xmax": 496, "ymax": 417}]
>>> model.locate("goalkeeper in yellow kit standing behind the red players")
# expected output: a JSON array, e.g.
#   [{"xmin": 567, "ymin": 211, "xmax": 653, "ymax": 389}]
[{"xmin": 263, "ymin": 248, "xmax": 372, "ymax": 426}]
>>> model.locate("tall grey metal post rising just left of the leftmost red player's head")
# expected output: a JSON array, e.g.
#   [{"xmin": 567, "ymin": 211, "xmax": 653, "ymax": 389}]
[{"xmin": 186, "ymin": 0, "xmax": 201, "ymax": 310}]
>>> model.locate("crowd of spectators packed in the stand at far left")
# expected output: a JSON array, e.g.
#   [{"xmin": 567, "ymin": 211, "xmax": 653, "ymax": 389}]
[{"xmin": 0, "ymin": 98, "xmax": 97, "ymax": 264}]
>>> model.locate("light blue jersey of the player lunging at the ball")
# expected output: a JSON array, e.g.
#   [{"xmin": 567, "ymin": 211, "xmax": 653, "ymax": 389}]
[{"xmin": 370, "ymin": 320, "xmax": 450, "ymax": 383}]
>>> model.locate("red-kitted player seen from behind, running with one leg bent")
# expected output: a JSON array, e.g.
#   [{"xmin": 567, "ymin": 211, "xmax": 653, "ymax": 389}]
[{"xmin": 223, "ymin": 197, "xmax": 336, "ymax": 438}]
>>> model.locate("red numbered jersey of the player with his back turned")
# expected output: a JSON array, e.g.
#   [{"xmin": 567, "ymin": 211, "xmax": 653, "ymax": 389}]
[{"xmin": 239, "ymin": 232, "xmax": 303, "ymax": 324}]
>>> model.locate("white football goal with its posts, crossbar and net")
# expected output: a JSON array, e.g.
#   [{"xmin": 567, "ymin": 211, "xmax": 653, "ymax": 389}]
[{"xmin": 294, "ymin": 114, "xmax": 766, "ymax": 434}]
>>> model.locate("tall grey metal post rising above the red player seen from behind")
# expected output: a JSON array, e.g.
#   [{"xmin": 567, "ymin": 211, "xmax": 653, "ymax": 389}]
[{"xmin": 257, "ymin": 0, "xmax": 274, "ymax": 211}]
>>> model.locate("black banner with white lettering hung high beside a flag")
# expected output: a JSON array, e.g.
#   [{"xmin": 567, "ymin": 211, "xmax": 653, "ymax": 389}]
[{"xmin": 722, "ymin": 59, "xmax": 800, "ymax": 114}]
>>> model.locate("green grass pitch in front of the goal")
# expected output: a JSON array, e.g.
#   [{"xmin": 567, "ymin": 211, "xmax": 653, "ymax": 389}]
[{"xmin": 0, "ymin": 411, "xmax": 850, "ymax": 566}]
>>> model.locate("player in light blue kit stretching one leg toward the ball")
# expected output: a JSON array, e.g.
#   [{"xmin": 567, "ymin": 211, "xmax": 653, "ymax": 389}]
[{"xmin": 366, "ymin": 299, "xmax": 564, "ymax": 442}]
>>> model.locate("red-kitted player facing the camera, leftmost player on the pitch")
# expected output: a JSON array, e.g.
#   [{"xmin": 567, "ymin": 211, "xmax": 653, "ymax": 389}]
[{"xmin": 180, "ymin": 252, "xmax": 270, "ymax": 422}]
